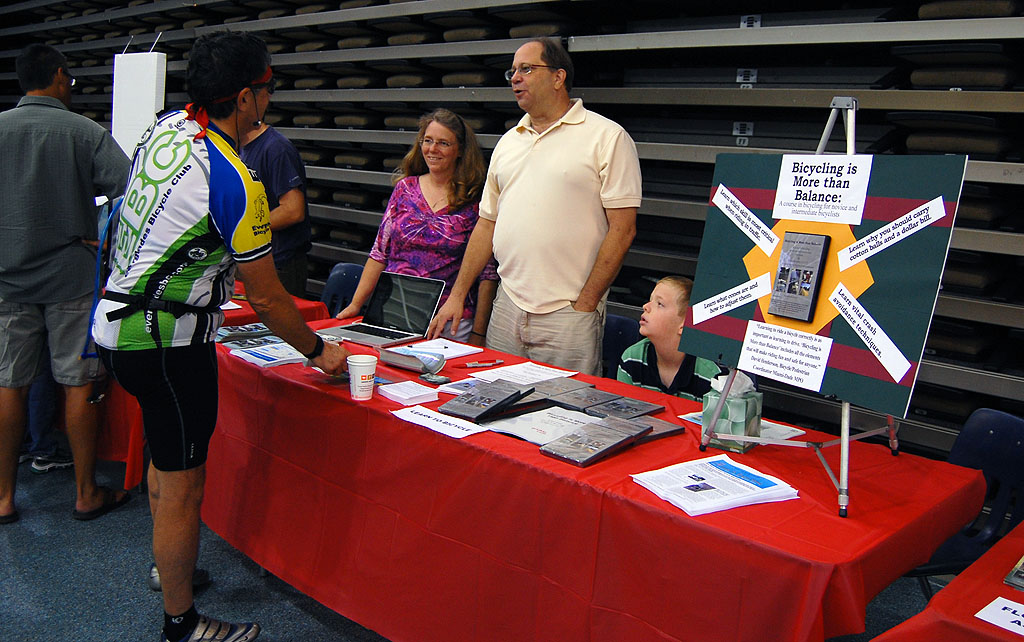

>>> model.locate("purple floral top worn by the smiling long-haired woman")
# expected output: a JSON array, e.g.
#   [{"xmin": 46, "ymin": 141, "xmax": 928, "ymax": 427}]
[{"xmin": 370, "ymin": 176, "xmax": 498, "ymax": 318}]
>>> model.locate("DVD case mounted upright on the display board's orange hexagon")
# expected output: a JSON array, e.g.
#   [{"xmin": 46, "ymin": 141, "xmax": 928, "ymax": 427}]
[{"xmin": 768, "ymin": 231, "xmax": 830, "ymax": 322}]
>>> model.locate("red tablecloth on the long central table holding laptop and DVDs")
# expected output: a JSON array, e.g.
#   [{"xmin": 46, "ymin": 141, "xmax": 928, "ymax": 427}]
[{"xmin": 197, "ymin": 322, "xmax": 984, "ymax": 642}]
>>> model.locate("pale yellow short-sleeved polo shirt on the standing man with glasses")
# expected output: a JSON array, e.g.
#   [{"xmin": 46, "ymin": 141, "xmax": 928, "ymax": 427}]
[{"xmin": 480, "ymin": 99, "xmax": 642, "ymax": 314}]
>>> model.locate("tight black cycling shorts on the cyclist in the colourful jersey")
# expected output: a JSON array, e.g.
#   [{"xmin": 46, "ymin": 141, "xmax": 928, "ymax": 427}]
[{"xmin": 99, "ymin": 343, "xmax": 217, "ymax": 471}]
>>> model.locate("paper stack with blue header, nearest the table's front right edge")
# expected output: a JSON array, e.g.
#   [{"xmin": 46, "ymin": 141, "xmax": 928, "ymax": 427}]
[{"xmin": 633, "ymin": 455, "xmax": 797, "ymax": 516}]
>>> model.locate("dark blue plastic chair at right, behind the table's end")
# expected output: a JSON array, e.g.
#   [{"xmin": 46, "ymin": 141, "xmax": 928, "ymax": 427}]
[{"xmin": 906, "ymin": 408, "xmax": 1024, "ymax": 599}]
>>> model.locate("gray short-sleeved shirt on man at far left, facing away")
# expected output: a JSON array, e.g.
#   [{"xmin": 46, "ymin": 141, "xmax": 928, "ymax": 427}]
[{"xmin": 0, "ymin": 96, "xmax": 131, "ymax": 303}]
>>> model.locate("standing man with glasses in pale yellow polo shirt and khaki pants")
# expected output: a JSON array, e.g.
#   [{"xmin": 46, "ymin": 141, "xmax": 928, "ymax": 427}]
[{"xmin": 430, "ymin": 38, "xmax": 641, "ymax": 374}]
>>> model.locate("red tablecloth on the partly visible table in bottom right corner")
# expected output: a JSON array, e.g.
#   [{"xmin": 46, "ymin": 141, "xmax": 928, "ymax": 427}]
[{"xmin": 874, "ymin": 524, "xmax": 1024, "ymax": 642}]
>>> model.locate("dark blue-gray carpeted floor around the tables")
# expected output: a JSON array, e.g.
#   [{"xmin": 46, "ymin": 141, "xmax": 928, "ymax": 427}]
[{"xmin": 0, "ymin": 463, "xmax": 937, "ymax": 642}]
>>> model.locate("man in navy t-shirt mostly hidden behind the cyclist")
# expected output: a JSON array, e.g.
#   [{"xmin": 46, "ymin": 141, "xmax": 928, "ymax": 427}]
[{"xmin": 242, "ymin": 121, "xmax": 312, "ymax": 297}]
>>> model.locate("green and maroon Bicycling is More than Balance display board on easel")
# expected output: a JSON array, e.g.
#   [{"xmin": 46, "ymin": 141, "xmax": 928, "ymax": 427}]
[{"xmin": 679, "ymin": 154, "xmax": 967, "ymax": 417}]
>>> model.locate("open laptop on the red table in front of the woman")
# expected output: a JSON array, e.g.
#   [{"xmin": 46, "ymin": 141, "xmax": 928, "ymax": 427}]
[{"xmin": 319, "ymin": 272, "xmax": 444, "ymax": 348}]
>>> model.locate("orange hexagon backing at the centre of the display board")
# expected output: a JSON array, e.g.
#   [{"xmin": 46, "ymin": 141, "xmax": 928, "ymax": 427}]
[{"xmin": 743, "ymin": 219, "xmax": 874, "ymax": 335}]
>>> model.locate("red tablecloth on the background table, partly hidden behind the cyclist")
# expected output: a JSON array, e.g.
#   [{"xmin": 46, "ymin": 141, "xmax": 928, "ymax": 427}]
[{"xmin": 96, "ymin": 294, "xmax": 329, "ymax": 489}]
